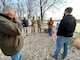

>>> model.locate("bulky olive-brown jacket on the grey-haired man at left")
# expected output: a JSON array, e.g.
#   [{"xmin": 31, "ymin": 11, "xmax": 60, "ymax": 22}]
[{"xmin": 0, "ymin": 13, "xmax": 23, "ymax": 56}]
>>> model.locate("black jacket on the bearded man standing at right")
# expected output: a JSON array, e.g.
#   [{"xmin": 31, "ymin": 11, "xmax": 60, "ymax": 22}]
[{"xmin": 57, "ymin": 15, "xmax": 76, "ymax": 37}]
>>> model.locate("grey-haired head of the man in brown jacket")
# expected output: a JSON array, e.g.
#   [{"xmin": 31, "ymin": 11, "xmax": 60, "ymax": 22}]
[{"xmin": 2, "ymin": 6, "xmax": 16, "ymax": 18}]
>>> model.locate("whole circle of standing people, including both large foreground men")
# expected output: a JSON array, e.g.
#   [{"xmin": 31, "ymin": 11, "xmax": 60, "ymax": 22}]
[{"xmin": 0, "ymin": 6, "xmax": 76, "ymax": 60}]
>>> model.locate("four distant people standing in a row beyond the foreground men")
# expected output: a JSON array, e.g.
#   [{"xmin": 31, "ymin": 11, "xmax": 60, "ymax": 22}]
[{"xmin": 22, "ymin": 17, "xmax": 54, "ymax": 37}]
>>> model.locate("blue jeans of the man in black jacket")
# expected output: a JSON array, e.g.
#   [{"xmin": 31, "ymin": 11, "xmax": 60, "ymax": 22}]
[{"xmin": 54, "ymin": 36, "xmax": 71, "ymax": 58}]
